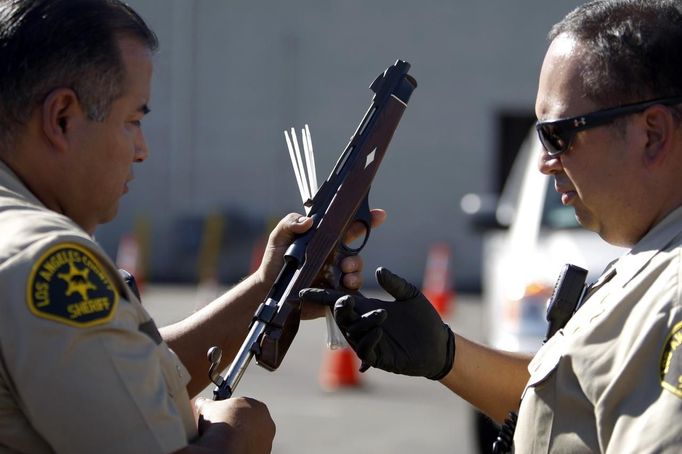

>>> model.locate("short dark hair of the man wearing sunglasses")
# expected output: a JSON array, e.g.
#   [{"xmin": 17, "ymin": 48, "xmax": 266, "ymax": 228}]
[{"xmin": 549, "ymin": 0, "xmax": 682, "ymax": 107}]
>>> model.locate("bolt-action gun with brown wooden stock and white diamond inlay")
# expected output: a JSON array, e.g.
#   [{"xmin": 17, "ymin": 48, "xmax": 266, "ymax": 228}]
[{"xmin": 208, "ymin": 60, "xmax": 417, "ymax": 400}]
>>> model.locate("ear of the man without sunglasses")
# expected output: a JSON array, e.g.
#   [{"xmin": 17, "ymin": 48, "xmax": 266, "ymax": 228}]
[{"xmin": 42, "ymin": 88, "xmax": 82, "ymax": 150}]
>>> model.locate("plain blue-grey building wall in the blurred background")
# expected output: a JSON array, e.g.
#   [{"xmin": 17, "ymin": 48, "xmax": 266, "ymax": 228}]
[{"xmin": 97, "ymin": 0, "xmax": 580, "ymax": 288}]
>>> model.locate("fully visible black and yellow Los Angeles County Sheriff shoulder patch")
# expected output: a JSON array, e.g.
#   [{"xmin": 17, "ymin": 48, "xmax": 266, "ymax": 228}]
[{"xmin": 26, "ymin": 243, "xmax": 118, "ymax": 327}]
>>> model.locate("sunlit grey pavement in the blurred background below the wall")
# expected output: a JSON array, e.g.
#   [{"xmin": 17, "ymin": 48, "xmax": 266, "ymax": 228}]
[{"xmin": 142, "ymin": 285, "xmax": 481, "ymax": 454}]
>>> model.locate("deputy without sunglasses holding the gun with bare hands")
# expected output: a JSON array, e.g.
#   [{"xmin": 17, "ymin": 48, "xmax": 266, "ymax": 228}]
[{"xmin": 0, "ymin": 0, "xmax": 384, "ymax": 454}]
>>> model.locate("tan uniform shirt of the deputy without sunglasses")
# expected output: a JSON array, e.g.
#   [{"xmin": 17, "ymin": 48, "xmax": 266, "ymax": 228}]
[{"xmin": 0, "ymin": 162, "xmax": 196, "ymax": 454}]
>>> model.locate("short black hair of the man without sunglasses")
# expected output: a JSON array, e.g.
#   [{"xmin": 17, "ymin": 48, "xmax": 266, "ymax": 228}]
[{"xmin": 0, "ymin": 0, "xmax": 158, "ymax": 148}]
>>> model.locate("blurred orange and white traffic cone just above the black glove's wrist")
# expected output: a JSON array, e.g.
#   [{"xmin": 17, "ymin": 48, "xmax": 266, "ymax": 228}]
[{"xmin": 422, "ymin": 243, "xmax": 455, "ymax": 317}]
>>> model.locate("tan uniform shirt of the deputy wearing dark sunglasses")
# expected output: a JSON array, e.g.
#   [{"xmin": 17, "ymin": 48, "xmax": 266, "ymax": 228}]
[{"xmin": 514, "ymin": 208, "xmax": 682, "ymax": 454}]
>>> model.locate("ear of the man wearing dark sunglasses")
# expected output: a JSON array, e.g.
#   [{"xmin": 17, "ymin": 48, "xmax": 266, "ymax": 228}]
[{"xmin": 644, "ymin": 105, "xmax": 677, "ymax": 166}]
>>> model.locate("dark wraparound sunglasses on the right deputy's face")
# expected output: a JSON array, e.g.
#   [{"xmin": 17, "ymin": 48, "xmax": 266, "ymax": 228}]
[{"xmin": 535, "ymin": 96, "xmax": 682, "ymax": 157}]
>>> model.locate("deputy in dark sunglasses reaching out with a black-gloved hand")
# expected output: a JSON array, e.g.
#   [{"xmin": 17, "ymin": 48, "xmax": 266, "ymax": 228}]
[{"xmin": 303, "ymin": 0, "xmax": 682, "ymax": 453}]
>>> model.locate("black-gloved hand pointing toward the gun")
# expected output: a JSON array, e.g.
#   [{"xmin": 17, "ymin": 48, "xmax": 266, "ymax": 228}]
[{"xmin": 299, "ymin": 268, "xmax": 455, "ymax": 380}]
